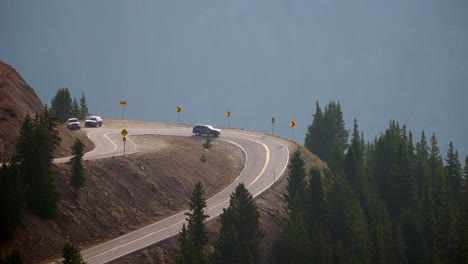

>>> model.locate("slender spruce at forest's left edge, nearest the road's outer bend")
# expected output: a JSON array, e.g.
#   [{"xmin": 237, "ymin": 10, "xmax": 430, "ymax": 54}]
[{"xmin": 285, "ymin": 149, "xmax": 307, "ymax": 214}]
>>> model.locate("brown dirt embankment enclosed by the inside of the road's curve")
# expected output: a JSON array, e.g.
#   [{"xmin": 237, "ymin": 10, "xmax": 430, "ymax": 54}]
[{"xmin": 0, "ymin": 135, "xmax": 245, "ymax": 263}]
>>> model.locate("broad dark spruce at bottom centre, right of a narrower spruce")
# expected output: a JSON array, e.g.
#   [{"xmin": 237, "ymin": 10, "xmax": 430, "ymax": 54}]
[{"xmin": 213, "ymin": 183, "xmax": 264, "ymax": 263}]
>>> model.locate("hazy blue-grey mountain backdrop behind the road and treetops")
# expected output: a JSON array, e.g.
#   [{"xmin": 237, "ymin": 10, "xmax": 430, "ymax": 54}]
[{"xmin": 0, "ymin": 0, "xmax": 468, "ymax": 159}]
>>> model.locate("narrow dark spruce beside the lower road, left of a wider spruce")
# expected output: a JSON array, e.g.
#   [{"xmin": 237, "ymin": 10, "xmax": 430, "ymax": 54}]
[{"xmin": 185, "ymin": 182, "xmax": 209, "ymax": 263}]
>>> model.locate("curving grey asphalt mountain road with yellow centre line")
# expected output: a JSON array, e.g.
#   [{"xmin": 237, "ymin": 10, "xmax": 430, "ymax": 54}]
[{"xmin": 55, "ymin": 126, "xmax": 289, "ymax": 264}]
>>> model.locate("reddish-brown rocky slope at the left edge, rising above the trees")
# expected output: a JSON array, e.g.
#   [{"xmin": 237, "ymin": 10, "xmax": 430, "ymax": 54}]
[{"xmin": 0, "ymin": 61, "xmax": 44, "ymax": 162}]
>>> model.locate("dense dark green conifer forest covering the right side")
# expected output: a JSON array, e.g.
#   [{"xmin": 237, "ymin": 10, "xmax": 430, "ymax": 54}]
[{"xmin": 271, "ymin": 102, "xmax": 468, "ymax": 263}]
